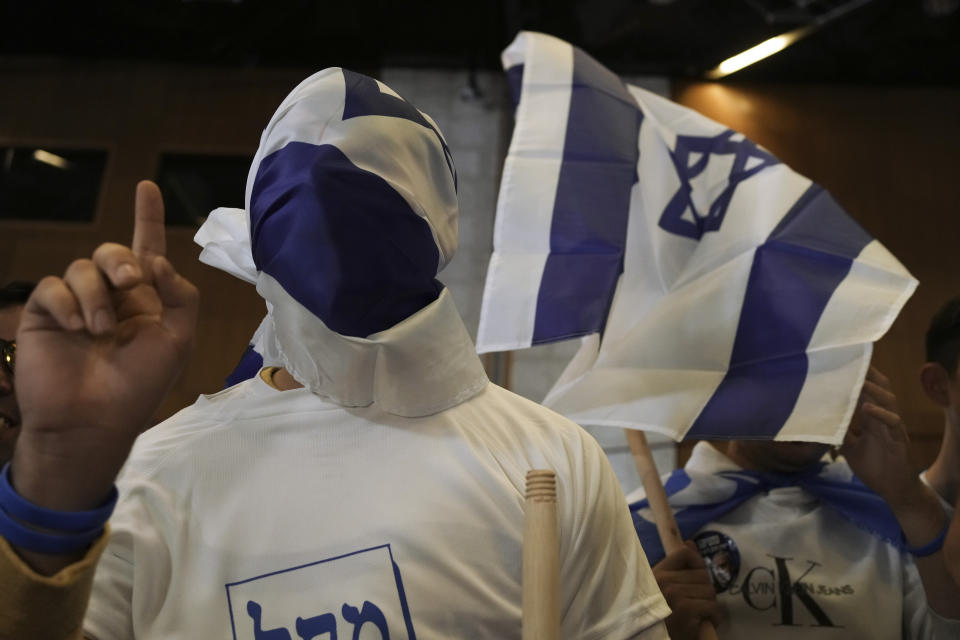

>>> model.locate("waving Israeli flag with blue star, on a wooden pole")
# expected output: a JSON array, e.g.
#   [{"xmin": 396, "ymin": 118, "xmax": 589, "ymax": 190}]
[{"xmin": 477, "ymin": 32, "xmax": 916, "ymax": 443}]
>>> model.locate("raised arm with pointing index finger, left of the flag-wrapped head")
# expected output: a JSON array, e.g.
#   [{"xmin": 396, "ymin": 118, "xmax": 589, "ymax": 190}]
[{"xmin": 0, "ymin": 182, "xmax": 198, "ymax": 638}]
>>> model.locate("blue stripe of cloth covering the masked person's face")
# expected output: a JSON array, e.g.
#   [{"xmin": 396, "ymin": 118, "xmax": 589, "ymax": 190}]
[{"xmin": 250, "ymin": 142, "xmax": 442, "ymax": 337}]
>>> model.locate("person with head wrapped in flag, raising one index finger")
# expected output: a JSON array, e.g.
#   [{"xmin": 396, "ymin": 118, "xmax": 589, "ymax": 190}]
[{"xmin": 0, "ymin": 68, "xmax": 669, "ymax": 640}]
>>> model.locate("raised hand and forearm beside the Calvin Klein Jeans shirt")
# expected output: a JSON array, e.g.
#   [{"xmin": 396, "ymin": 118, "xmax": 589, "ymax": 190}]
[{"xmin": 842, "ymin": 368, "xmax": 960, "ymax": 620}]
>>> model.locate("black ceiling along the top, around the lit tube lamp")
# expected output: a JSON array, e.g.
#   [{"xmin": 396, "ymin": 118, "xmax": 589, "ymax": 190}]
[{"xmin": 0, "ymin": 0, "xmax": 960, "ymax": 86}]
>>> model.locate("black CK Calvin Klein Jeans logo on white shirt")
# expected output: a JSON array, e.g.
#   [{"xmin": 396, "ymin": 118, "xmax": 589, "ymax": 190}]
[{"xmin": 730, "ymin": 555, "xmax": 854, "ymax": 629}]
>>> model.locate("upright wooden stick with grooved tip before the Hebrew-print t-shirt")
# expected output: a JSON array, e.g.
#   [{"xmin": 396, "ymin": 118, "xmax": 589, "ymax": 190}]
[{"xmin": 522, "ymin": 469, "xmax": 560, "ymax": 640}]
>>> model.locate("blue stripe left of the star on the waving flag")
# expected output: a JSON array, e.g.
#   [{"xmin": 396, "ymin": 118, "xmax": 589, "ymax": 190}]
[{"xmin": 532, "ymin": 48, "xmax": 643, "ymax": 344}]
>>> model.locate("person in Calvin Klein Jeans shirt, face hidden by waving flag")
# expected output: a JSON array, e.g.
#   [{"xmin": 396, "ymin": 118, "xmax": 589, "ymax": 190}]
[{"xmin": 628, "ymin": 369, "xmax": 960, "ymax": 639}]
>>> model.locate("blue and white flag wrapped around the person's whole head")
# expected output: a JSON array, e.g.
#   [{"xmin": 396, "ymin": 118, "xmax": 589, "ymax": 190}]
[{"xmin": 195, "ymin": 68, "xmax": 488, "ymax": 414}]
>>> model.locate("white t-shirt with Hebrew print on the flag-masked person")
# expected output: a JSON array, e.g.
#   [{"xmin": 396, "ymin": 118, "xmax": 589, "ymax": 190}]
[{"xmin": 84, "ymin": 377, "xmax": 669, "ymax": 640}]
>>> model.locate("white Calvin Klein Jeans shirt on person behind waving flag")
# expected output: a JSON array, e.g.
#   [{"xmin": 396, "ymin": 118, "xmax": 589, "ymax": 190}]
[{"xmin": 628, "ymin": 442, "xmax": 960, "ymax": 640}]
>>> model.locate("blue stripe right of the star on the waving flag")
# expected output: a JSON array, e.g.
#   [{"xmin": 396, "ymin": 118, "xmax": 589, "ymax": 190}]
[{"xmin": 685, "ymin": 185, "xmax": 872, "ymax": 438}]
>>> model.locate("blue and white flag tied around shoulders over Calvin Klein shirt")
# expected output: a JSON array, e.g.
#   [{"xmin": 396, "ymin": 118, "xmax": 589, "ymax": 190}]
[{"xmin": 630, "ymin": 463, "xmax": 905, "ymax": 566}]
